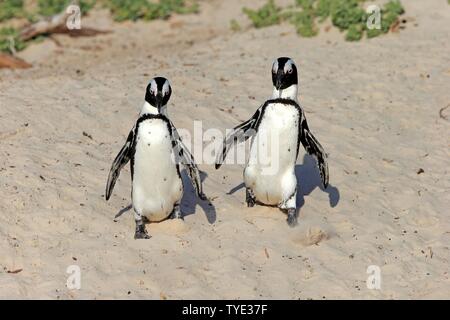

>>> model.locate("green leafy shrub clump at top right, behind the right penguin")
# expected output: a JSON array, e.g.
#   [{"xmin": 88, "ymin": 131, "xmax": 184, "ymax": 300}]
[{"xmin": 243, "ymin": 0, "xmax": 404, "ymax": 41}]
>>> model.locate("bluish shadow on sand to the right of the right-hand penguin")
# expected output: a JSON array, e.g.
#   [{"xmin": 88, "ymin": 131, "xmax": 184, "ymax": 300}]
[{"xmin": 295, "ymin": 154, "xmax": 340, "ymax": 210}]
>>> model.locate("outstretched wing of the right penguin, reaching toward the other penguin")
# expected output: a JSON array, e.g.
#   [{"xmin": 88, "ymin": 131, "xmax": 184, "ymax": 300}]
[{"xmin": 216, "ymin": 107, "xmax": 262, "ymax": 169}]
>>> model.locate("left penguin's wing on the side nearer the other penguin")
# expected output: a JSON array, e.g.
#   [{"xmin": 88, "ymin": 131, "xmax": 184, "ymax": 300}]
[{"xmin": 170, "ymin": 123, "xmax": 207, "ymax": 200}]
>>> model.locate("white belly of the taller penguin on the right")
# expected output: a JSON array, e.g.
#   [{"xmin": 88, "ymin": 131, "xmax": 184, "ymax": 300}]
[{"xmin": 244, "ymin": 104, "xmax": 299, "ymax": 205}]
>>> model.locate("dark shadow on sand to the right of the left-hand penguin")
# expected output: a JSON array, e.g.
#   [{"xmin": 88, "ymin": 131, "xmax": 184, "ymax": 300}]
[{"xmin": 181, "ymin": 170, "xmax": 217, "ymax": 224}]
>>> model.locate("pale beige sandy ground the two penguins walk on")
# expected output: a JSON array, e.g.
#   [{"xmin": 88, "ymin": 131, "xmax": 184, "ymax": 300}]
[{"xmin": 0, "ymin": 0, "xmax": 450, "ymax": 299}]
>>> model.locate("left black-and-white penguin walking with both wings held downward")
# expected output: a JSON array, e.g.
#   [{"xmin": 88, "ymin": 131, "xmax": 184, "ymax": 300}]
[{"xmin": 105, "ymin": 77, "xmax": 206, "ymax": 239}]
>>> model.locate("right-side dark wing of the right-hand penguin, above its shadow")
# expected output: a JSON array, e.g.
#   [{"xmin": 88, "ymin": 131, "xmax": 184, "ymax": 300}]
[{"xmin": 297, "ymin": 114, "xmax": 329, "ymax": 188}]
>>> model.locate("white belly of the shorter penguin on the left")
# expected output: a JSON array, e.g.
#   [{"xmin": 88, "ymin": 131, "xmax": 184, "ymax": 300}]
[{"xmin": 132, "ymin": 119, "xmax": 183, "ymax": 221}]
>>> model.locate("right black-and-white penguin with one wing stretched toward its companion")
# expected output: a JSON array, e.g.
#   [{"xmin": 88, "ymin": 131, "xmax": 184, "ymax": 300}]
[{"xmin": 215, "ymin": 57, "xmax": 329, "ymax": 227}]
